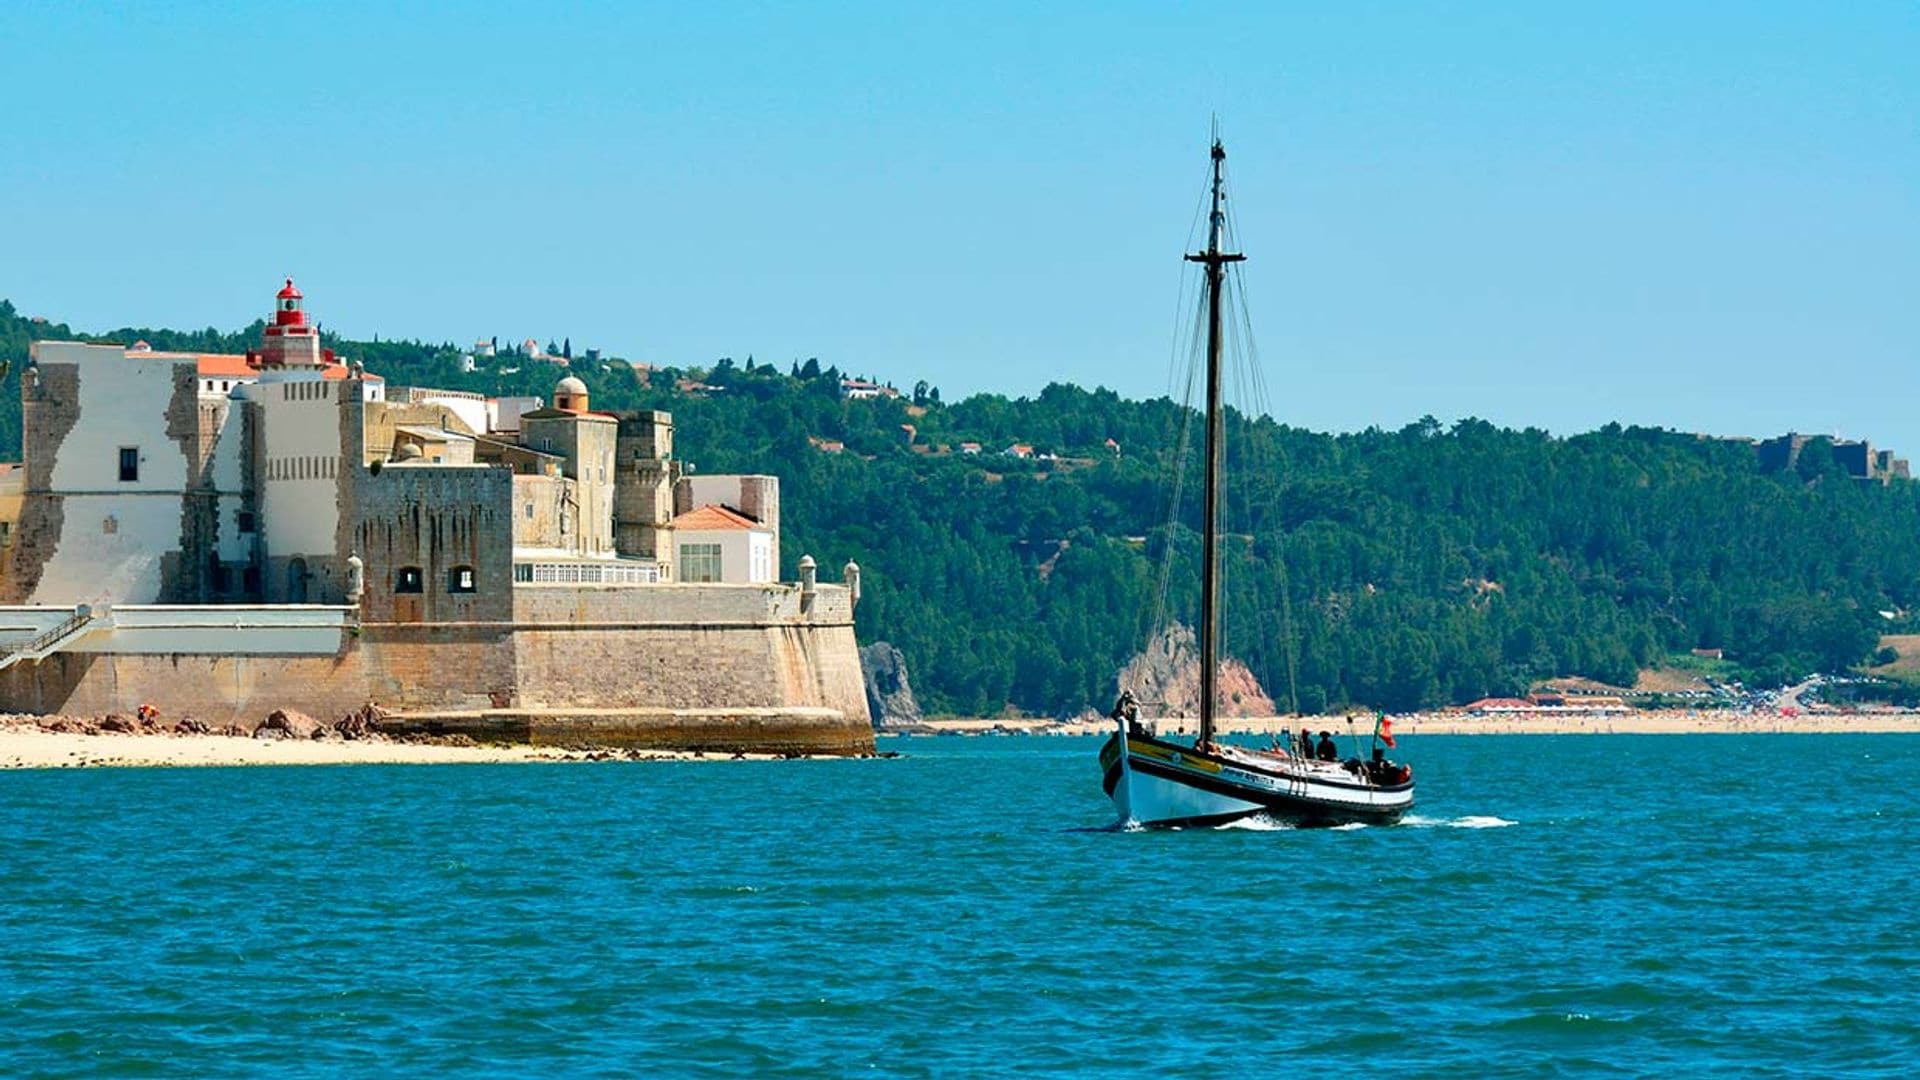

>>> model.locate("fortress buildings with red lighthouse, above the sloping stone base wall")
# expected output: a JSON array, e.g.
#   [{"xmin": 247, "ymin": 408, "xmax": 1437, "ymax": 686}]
[{"xmin": 11, "ymin": 281, "xmax": 780, "ymax": 621}]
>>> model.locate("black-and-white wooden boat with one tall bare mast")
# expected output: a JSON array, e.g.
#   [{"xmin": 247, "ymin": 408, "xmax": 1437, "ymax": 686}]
[{"xmin": 1100, "ymin": 138, "xmax": 1413, "ymax": 826}]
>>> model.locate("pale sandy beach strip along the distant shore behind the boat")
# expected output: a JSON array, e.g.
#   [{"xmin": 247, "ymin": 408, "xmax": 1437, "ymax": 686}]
[{"xmin": 879, "ymin": 709, "xmax": 1920, "ymax": 738}]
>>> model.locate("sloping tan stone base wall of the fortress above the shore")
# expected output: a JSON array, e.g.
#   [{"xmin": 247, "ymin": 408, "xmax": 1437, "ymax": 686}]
[{"xmin": 0, "ymin": 586, "xmax": 874, "ymax": 753}]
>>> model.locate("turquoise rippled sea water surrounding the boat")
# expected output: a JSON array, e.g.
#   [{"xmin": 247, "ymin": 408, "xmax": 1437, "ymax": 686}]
[{"xmin": 0, "ymin": 736, "xmax": 1920, "ymax": 1076}]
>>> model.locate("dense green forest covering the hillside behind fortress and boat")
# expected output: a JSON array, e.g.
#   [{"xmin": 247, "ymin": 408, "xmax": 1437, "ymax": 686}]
[{"xmin": 0, "ymin": 297, "xmax": 1920, "ymax": 713}]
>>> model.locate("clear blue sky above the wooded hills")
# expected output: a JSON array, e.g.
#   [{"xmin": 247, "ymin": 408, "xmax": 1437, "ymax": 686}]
[{"xmin": 0, "ymin": 0, "xmax": 1920, "ymax": 441}]
